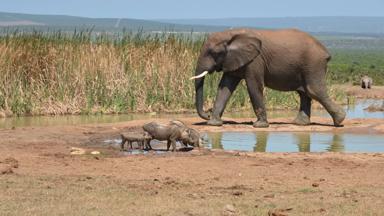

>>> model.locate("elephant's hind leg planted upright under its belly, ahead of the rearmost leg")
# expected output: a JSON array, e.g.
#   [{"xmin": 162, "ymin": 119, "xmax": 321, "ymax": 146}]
[{"xmin": 294, "ymin": 90, "xmax": 312, "ymax": 125}]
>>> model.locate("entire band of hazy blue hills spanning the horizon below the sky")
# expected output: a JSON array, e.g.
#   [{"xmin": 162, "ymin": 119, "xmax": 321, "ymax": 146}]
[{"xmin": 0, "ymin": 12, "xmax": 384, "ymax": 36}]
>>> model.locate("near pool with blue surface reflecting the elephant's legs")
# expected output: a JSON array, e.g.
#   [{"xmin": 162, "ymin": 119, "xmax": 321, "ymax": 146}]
[{"xmin": 203, "ymin": 132, "xmax": 384, "ymax": 152}]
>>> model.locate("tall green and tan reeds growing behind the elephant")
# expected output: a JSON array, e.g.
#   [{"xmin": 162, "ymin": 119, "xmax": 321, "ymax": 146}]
[{"xmin": 0, "ymin": 32, "xmax": 381, "ymax": 115}]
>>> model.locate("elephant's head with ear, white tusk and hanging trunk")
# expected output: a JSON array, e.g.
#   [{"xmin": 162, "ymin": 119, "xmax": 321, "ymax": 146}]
[{"xmin": 191, "ymin": 32, "xmax": 261, "ymax": 120}]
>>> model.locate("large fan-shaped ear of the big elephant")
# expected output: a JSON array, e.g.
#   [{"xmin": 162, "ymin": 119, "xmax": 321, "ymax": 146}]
[{"xmin": 223, "ymin": 35, "xmax": 261, "ymax": 72}]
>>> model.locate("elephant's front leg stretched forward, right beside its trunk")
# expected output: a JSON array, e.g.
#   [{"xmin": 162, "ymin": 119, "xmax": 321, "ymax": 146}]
[{"xmin": 207, "ymin": 74, "xmax": 241, "ymax": 126}]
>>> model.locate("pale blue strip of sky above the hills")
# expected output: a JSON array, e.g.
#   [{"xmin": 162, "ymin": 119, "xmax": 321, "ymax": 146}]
[{"xmin": 0, "ymin": 0, "xmax": 384, "ymax": 19}]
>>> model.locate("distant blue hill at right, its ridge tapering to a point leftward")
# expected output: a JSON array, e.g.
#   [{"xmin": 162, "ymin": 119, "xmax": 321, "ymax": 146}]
[{"xmin": 158, "ymin": 17, "xmax": 384, "ymax": 34}]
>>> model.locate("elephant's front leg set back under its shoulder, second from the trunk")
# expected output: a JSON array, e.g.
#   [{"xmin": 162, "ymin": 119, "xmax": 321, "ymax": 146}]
[{"xmin": 245, "ymin": 76, "xmax": 269, "ymax": 128}]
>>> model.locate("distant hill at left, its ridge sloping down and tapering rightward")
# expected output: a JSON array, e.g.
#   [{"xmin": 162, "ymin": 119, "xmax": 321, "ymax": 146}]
[{"xmin": 0, "ymin": 12, "xmax": 226, "ymax": 32}]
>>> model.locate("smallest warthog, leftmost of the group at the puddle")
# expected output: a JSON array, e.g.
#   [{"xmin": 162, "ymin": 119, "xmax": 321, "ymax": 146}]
[{"xmin": 120, "ymin": 132, "xmax": 152, "ymax": 151}]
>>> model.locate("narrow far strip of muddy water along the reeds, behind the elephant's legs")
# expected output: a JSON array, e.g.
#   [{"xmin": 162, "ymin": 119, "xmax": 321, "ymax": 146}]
[{"xmin": 0, "ymin": 99, "xmax": 384, "ymax": 128}]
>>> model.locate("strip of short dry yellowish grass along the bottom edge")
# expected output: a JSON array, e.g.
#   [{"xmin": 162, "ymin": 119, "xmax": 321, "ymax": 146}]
[{"xmin": 0, "ymin": 169, "xmax": 384, "ymax": 215}]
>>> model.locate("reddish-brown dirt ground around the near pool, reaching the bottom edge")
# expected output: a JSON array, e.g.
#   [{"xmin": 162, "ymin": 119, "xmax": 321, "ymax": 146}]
[{"xmin": 0, "ymin": 85, "xmax": 384, "ymax": 216}]
